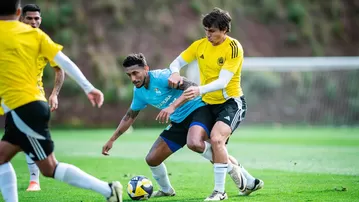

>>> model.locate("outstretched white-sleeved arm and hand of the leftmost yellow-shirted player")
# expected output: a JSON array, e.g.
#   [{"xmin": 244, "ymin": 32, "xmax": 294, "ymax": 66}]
[{"xmin": 54, "ymin": 51, "xmax": 104, "ymax": 107}]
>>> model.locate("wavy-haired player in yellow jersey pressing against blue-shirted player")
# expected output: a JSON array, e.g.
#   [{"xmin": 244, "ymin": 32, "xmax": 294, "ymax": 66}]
[{"xmin": 169, "ymin": 8, "xmax": 264, "ymax": 201}]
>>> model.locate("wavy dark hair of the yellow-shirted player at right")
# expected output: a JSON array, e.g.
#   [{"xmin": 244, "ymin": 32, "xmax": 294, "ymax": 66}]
[{"xmin": 202, "ymin": 8, "xmax": 232, "ymax": 32}]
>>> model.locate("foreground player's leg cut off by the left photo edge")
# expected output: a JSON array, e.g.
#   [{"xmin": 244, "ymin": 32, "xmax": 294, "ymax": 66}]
[{"xmin": 0, "ymin": 123, "xmax": 21, "ymax": 202}]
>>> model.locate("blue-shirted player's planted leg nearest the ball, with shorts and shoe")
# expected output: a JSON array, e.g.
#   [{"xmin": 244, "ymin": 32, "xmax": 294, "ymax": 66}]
[{"xmin": 146, "ymin": 123, "xmax": 186, "ymax": 197}]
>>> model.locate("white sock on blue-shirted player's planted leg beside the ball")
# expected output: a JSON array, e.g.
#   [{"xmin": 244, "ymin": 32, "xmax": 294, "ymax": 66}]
[{"xmin": 150, "ymin": 163, "xmax": 172, "ymax": 193}]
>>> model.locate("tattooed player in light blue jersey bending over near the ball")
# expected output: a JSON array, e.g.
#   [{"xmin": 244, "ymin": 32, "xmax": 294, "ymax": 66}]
[{"xmin": 102, "ymin": 53, "xmax": 245, "ymax": 197}]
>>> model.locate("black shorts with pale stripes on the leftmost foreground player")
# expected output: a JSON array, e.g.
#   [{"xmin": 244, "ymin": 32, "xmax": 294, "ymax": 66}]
[{"xmin": 2, "ymin": 101, "xmax": 54, "ymax": 161}]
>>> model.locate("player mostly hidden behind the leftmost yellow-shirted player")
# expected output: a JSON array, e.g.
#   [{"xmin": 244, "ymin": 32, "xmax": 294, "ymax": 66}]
[{"xmin": 19, "ymin": 4, "xmax": 65, "ymax": 191}]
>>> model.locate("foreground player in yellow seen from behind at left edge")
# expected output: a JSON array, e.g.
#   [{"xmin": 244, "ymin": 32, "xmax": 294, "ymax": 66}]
[{"xmin": 0, "ymin": 0, "xmax": 122, "ymax": 202}]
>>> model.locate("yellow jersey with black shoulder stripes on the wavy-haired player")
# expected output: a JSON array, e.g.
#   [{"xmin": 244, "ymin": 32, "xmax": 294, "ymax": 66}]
[{"xmin": 181, "ymin": 36, "xmax": 243, "ymax": 104}]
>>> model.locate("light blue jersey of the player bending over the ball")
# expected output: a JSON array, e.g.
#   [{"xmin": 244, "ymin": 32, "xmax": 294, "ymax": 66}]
[{"xmin": 131, "ymin": 69, "xmax": 205, "ymax": 123}]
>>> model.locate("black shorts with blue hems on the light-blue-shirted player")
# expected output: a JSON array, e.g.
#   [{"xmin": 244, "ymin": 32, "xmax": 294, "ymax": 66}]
[{"xmin": 160, "ymin": 106, "xmax": 213, "ymax": 153}]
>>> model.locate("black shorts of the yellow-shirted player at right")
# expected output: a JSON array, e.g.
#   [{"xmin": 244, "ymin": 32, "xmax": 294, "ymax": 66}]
[{"xmin": 207, "ymin": 96, "xmax": 247, "ymax": 133}]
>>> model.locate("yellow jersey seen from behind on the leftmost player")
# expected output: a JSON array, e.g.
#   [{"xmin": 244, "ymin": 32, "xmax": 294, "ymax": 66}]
[{"xmin": 0, "ymin": 20, "xmax": 62, "ymax": 114}]
